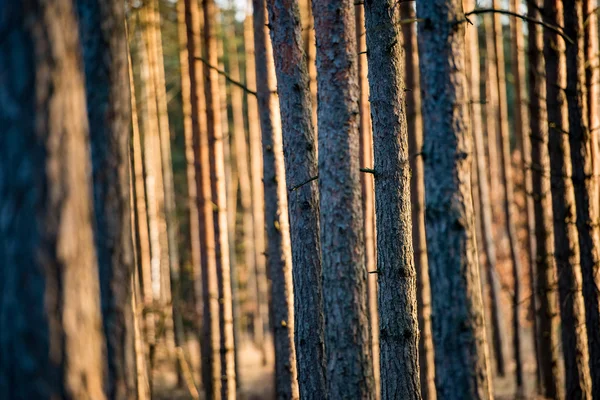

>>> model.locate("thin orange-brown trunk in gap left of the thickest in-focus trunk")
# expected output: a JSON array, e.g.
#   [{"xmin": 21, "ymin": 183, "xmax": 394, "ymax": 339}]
[{"xmin": 401, "ymin": 3, "xmax": 436, "ymax": 400}]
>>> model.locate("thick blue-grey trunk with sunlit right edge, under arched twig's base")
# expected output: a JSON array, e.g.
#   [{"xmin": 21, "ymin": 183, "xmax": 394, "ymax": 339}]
[{"xmin": 417, "ymin": 0, "xmax": 491, "ymax": 399}]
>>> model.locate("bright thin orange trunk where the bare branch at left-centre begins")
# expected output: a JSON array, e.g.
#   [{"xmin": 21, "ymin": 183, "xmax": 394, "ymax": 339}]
[{"xmin": 203, "ymin": 0, "xmax": 236, "ymax": 399}]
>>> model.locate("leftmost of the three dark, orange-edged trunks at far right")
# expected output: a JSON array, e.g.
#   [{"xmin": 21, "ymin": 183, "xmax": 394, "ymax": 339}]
[{"xmin": 523, "ymin": 0, "xmax": 558, "ymax": 394}]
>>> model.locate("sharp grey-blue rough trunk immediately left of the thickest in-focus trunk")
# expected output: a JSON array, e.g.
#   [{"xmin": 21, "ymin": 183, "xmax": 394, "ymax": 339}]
[{"xmin": 365, "ymin": 0, "xmax": 421, "ymax": 399}]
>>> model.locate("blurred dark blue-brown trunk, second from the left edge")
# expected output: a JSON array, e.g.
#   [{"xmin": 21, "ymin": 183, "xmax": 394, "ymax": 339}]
[{"xmin": 76, "ymin": 0, "xmax": 136, "ymax": 399}]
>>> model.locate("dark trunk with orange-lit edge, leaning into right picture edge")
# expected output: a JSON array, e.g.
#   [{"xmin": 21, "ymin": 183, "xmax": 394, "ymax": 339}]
[{"xmin": 560, "ymin": 0, "xmax": 600, "ymax": 398}]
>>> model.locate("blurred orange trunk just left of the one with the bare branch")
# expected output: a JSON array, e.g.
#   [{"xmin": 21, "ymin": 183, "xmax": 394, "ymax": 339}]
[{"xmin": 185, "ymin": 0, "xmax": 221, "ymax": 400}]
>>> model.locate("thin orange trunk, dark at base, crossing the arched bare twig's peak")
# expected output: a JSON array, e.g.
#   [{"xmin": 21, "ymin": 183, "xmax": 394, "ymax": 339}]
[{"xmin": 492, "ymin": 0, "xmax": 523, "ymax": 388}]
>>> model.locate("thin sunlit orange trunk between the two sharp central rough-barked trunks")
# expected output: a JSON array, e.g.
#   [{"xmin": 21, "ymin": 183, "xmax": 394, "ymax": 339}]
[{"xmin": 355, "ymin": 4, "xmax": 381, "ymax": 398}]
